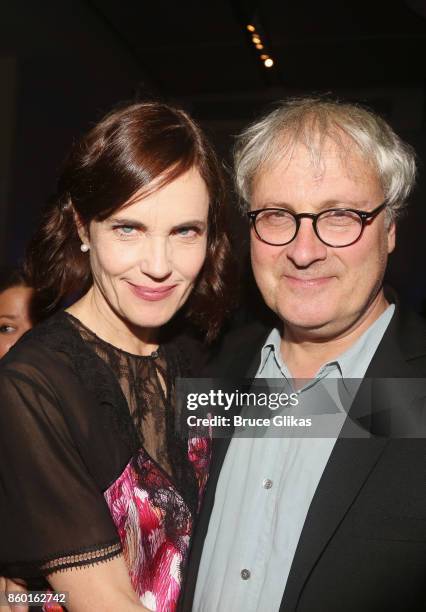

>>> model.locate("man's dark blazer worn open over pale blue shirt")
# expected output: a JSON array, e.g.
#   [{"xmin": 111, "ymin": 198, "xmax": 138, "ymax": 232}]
[{"xmin": 181, "ymin": 306, "xmax": 426, "ymax": 612}]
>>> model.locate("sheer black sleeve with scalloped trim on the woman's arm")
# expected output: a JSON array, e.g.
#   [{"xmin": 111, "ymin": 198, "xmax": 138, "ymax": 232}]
[{"xmin": 0, "ymin": 361, "xmax": 121, "ymax": 579}]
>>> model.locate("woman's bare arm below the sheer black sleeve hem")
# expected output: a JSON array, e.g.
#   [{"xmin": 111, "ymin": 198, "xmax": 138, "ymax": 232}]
[{"xmin": 48, "ymin": 556, "xmax": 149, "ymax": 612}]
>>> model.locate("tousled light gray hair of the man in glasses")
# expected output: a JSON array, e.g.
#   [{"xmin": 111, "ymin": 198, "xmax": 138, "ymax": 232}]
[{"xmin": 234, "ymin": 98, "xmax": 416, "ymax": 221}]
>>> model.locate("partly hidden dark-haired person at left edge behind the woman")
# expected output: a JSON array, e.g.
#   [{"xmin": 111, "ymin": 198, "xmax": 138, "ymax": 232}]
[{"xmin": 0, "ymin": 266, "xmax": 37, "ymax": 358}]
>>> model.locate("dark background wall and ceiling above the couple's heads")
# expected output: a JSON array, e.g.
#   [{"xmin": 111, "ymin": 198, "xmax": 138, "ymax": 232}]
[{"xmin": 0, "ymin": 0, "xmax": 426, "ymax": 310}]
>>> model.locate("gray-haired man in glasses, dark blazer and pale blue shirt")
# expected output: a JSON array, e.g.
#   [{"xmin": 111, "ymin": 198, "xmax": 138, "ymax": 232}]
[{"xmin": 182, "ymin": 99, "xmax": 426, "ymax": 612}]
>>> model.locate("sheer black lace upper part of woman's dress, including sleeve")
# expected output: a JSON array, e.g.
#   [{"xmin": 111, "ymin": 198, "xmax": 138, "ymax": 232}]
[{"xmin": 0, "ymin": 313, "xmax": 208, "ymax": 588}]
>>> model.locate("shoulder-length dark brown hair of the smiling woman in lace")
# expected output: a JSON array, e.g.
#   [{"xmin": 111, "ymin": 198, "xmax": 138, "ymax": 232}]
[{"xmin": 26, "ymin": 102, "xmax": 234, "ymax": 340}]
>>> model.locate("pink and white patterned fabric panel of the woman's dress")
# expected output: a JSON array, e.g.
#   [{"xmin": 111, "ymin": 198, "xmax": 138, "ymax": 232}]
[{"xmin": 104, "ymin": 438, "xmax": 211, "ymax": 612}]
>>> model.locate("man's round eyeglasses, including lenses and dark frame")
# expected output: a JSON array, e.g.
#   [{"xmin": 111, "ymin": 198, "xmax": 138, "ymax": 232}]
[{"xmin": 247, "ymin": 202, "xmax": 386, "ymax": 248}]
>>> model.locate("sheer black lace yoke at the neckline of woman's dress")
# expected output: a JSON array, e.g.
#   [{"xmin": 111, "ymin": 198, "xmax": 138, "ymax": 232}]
[{"xmin": 22, "ymin": 310, "xmax": 198, "ymax": 511}]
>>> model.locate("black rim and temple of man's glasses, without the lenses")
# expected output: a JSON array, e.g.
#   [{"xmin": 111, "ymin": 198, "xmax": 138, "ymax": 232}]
[{"xmin": 246, "ymin": 202, "xmax": 387, "ymax": 249}]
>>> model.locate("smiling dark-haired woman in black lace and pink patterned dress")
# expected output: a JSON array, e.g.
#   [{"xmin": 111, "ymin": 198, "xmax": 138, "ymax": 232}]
[{"xmin": 0, "ymin": 103, "xmax": 231, "ymax": 612}]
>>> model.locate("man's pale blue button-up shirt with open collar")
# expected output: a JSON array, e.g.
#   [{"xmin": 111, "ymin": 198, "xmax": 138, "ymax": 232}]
[{"xmin": 193, "ymin": 305, "xmax": 395, "ymax": 612}]
